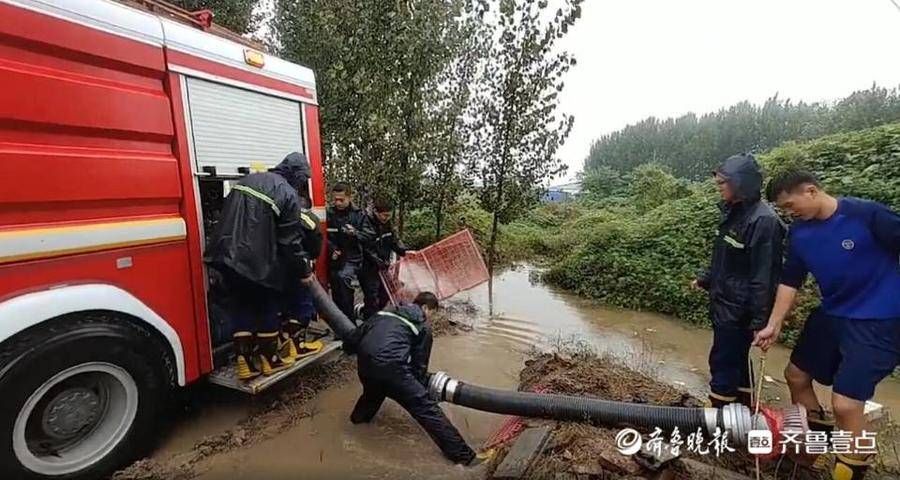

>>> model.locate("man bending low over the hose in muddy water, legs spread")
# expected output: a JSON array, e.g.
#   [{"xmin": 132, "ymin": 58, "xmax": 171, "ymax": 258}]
[{"xmin": 350, "ymin": 292, "xmax": 483, "ymax": 465}]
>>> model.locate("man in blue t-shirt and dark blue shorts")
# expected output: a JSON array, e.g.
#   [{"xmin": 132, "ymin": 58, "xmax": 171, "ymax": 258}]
[{"xmin": 754, "ymin": 171, "xmax": 900, "ymax": 480}]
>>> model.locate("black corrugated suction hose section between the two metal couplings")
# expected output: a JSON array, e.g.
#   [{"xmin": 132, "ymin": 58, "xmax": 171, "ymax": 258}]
[{"xmin": 447, "ymin": 382, "xmax": 707, "ymax": 432}]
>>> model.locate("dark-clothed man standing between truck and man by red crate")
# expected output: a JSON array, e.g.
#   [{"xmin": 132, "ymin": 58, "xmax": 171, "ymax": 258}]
[{"xmin": 327, "ymin": 183, "xmax": 375, "ymax": 320}]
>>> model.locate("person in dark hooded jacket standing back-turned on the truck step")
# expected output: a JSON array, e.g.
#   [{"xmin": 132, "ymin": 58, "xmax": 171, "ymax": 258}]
[{"xmin": 205, "ymin": 152, "xmax": 312, "ymax": 380}]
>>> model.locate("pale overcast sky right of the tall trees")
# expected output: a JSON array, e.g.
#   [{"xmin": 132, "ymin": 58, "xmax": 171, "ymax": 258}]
[{"xmin": 562, "ymin": 0, "xmax": 900, "ymax": 178}]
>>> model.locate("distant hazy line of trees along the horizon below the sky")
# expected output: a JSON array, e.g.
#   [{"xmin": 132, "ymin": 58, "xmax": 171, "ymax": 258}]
[{"xmin": 585, "ymin": 85, "xmax": 900, "ymax": 179}]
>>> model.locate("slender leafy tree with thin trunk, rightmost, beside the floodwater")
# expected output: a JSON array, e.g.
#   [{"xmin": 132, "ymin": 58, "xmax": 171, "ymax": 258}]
[{"xmin": 469, "ymin": 0, "xmax": 583, "ymax": 270}]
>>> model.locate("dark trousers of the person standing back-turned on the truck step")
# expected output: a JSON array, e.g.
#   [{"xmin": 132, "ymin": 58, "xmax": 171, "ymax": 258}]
[{"xmin": 222, "ymin": 269, "xmax": 282, "ymax": 333}]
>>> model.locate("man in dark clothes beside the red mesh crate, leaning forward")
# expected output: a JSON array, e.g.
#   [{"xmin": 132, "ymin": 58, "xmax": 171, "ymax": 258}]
[{"xmin": 359, "ymin": 199, "xmax": 407, "ymax": 319}]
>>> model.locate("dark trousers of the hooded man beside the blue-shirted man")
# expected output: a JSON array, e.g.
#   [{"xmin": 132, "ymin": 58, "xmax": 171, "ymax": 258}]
[{"xmin": 709, "ymin": 326, "xmax": 753, "ymax": 401}]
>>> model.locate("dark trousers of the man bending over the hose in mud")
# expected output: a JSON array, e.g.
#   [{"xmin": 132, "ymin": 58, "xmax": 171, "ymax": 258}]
[{"xmin": 350, "ymin": 367, "xmax": 475, "ymax": 464}]
